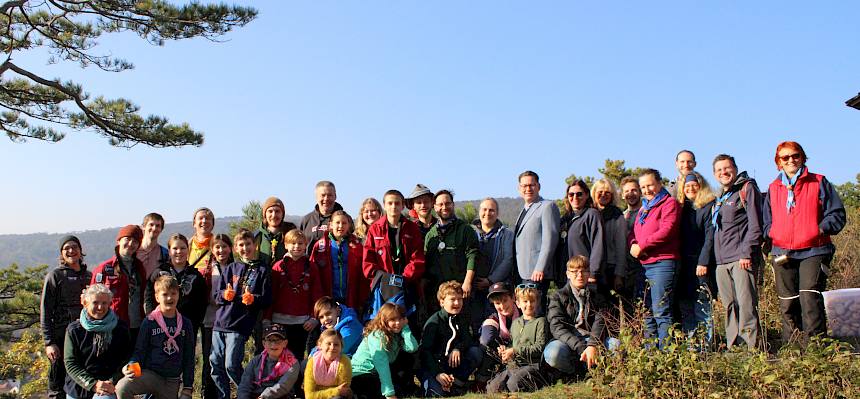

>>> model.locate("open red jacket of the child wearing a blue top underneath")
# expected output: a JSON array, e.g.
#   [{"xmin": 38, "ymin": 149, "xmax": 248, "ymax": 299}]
[{"xmin": 311, "ymin": 234, "xmax": 370, "ymax": 311}]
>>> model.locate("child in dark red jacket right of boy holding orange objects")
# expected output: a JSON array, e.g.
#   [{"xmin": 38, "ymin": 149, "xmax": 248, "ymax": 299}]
[{"xmin": 263, "ymin": 229, "xmax": 323, "ymax": 358}]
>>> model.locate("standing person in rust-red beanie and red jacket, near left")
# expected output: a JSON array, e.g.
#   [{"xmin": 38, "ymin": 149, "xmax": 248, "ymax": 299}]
[{"xmin": 90, "ymin": 224, "xmax": 146, "ymax": 342}]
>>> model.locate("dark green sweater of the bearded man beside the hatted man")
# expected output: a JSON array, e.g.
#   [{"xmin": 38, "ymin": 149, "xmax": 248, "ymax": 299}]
[{"xmin": 424, "ymin": 219, "xmax": 480, "ymax": 284}]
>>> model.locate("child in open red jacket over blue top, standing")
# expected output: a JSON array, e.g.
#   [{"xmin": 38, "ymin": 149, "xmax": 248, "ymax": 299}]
[{"xmin": 310, "ymin": 211, "xmax": 370, "ymax": 314}]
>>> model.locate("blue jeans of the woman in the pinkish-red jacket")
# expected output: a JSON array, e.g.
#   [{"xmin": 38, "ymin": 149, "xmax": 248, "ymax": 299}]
[{"xmin": 642, "ymin": 260, "xmax": 675, "ymax": 348}]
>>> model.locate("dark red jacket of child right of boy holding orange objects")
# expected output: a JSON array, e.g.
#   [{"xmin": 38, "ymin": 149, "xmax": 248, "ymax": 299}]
[{"xmin": 266, "ymin": 256, "xmax": 323, "ymax": 320}]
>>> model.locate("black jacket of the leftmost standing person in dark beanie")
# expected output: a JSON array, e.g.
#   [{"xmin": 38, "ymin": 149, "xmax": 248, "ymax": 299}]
[{"xmin": 39, "ymin": 262, "xmax": 92, "ymax": 346}]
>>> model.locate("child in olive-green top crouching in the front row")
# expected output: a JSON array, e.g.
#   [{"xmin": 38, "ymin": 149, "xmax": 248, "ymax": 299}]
[{"xmin": 487, "ymin": 284, "xmax": 549, "ymax": 393}]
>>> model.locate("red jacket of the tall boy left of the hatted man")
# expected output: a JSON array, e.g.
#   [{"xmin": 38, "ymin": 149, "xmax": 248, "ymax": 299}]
[{"xmin": 363, "ymin": 216, "xmax": 424, "ymax": 283}]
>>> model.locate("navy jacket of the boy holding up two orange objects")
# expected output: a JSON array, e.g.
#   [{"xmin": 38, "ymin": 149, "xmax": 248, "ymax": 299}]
[{"xmin": 212, "ymin": 259, "xmax": 272, "ymax": 337}]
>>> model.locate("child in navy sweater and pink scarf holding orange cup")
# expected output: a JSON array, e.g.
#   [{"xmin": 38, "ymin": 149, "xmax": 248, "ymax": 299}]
[{"xmin": 116, "ymin": 276, "xmax": 197, "ymax": 399}]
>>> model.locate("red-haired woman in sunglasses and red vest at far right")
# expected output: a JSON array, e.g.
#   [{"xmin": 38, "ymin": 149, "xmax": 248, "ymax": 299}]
[{"xmin": 762, "ymin": 141, "xmax": 846, "ymax": 343}]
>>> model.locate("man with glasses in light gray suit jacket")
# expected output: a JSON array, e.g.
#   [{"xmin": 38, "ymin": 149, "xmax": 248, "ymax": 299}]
[{"xmin": 514, "ymin": 170, "xmax": 561, "ymax": 314}]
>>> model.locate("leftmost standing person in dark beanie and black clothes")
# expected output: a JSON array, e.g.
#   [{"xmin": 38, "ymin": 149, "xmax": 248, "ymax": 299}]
[{"xmin": 39, "ymin": 236, "xmax": 92, "ymax": 398}]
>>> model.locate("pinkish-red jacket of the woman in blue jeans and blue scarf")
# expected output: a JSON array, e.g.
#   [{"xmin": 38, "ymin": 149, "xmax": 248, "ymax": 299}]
[{"xmin": 630, "ymin": 195, "xmax": 681, "ymax": 265}]
